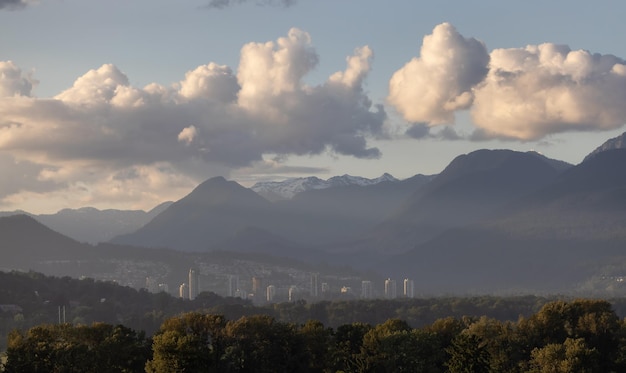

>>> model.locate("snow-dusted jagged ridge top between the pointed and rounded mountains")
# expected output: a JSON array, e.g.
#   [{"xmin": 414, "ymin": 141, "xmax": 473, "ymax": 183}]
[{"xmin": 250, "ymin": 173, "xmax": 398, "ymax": 201}]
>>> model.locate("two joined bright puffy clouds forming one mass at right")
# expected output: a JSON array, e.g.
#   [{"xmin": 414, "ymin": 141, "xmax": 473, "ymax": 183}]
[{"xmin": 388, "ymin": 23, "xmax": 626, "ymax": 141}]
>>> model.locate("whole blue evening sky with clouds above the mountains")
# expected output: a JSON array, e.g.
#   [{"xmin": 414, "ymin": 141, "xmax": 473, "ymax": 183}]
[{"xmin": 0, "ymin": 0, "xmax": 626, "ymax": 213}]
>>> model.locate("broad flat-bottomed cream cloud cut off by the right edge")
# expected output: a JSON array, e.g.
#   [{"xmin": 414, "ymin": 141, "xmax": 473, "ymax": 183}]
[{"xmin": 471, "ymin": 43, "xmax": 626, "ymax": 140}]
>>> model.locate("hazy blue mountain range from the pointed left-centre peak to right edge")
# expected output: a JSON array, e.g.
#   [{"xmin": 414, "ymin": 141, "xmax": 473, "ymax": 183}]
[{"xmin": 0, "ymin": 134, "xmax": 626, "ymax": 294}]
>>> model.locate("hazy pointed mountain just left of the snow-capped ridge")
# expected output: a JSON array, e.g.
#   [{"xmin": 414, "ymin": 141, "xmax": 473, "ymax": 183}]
[{"xmin": 112, "ymin": 177, "xmax": 271, "ymax": 251}]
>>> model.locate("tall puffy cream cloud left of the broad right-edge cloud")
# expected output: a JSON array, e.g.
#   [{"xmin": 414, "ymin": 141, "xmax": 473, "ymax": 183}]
[{"xmin": 388, "ymin": 23, "xmax": 489, "ymax": 125}]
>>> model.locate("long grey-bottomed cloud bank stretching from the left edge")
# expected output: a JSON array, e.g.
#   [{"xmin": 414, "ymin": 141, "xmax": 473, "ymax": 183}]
[{"xmin": 0, "ymin": 29, "xmax": 386, "ymax": 211}]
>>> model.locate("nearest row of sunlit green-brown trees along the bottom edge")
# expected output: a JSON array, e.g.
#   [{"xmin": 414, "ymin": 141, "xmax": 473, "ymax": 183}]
[{"xmin": 4, "ymin": 300, "xmax": 626, "ymax": 373}]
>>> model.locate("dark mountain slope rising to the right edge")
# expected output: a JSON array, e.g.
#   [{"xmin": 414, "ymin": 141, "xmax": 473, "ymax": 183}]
[{"xmin": 382, "ymin": 149, "xmax": 626, "ymax": 293}]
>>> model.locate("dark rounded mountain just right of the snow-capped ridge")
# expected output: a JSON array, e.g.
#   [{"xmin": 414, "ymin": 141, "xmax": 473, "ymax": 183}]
[{"xmin": 350, "ymin": 150, "xmax": 565, "ymax": 253}]
